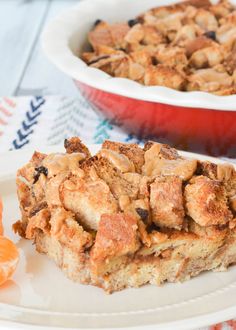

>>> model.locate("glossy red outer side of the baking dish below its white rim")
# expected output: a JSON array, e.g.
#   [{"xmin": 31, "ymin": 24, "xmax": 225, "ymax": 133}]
[{"xmin": 76, "ymin": 81, "xmax": 236, "ymax": 157}]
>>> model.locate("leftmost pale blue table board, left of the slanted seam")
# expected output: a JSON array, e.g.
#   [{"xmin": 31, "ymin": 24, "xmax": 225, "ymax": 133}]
[{"xmin": 0, "ymin": 0, "xmax": 50, "ymax": 95}]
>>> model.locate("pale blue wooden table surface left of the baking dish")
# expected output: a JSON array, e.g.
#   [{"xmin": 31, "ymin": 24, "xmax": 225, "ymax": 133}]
[{"xmin": 0, "ymin": 0, "xmax": 78, "ymax": 96}]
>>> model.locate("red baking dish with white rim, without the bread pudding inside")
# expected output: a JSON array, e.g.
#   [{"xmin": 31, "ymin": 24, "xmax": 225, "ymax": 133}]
[{"xmin": 42, "ymin": 0, "xmax": 236, "ymax": 157}]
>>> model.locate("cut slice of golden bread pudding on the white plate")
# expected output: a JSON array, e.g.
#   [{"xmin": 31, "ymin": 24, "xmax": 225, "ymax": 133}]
[{"xmin": 14, "ymin": 138, "xmax": 236, "ymax": 292}]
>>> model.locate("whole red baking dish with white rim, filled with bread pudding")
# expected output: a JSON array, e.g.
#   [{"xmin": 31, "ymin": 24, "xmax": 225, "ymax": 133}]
[{"xmin": 42, "ymin": 0, "xmax": 236, "ymax": 158}]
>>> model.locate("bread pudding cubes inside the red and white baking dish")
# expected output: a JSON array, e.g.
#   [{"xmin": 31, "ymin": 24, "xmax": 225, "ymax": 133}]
[{"xmin": 82, "ymin": 0, "xmax": 236, "ymax": 95}]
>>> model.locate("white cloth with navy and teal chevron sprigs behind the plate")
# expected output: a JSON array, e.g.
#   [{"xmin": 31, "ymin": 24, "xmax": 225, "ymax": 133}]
[{"xmin": 0, "ymin": 96, "xmax": 142, "ymax": 152}]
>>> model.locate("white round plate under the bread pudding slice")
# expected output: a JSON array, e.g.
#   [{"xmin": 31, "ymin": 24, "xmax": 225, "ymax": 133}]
[{"xmin": 0, "ymin": 146, "xmax": 236, "ymax": 330}]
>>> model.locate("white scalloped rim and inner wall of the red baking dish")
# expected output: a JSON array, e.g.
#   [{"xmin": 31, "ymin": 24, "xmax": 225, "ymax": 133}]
[{"xmin": 42, "ymin": 0, "xmax": 236, "ymax": 111}]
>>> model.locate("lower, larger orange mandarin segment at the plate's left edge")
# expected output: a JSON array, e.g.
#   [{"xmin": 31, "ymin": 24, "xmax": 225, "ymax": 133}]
[{"xmin": 0, "ymin": 236, "xmax": 19, "ymax": 285}]
